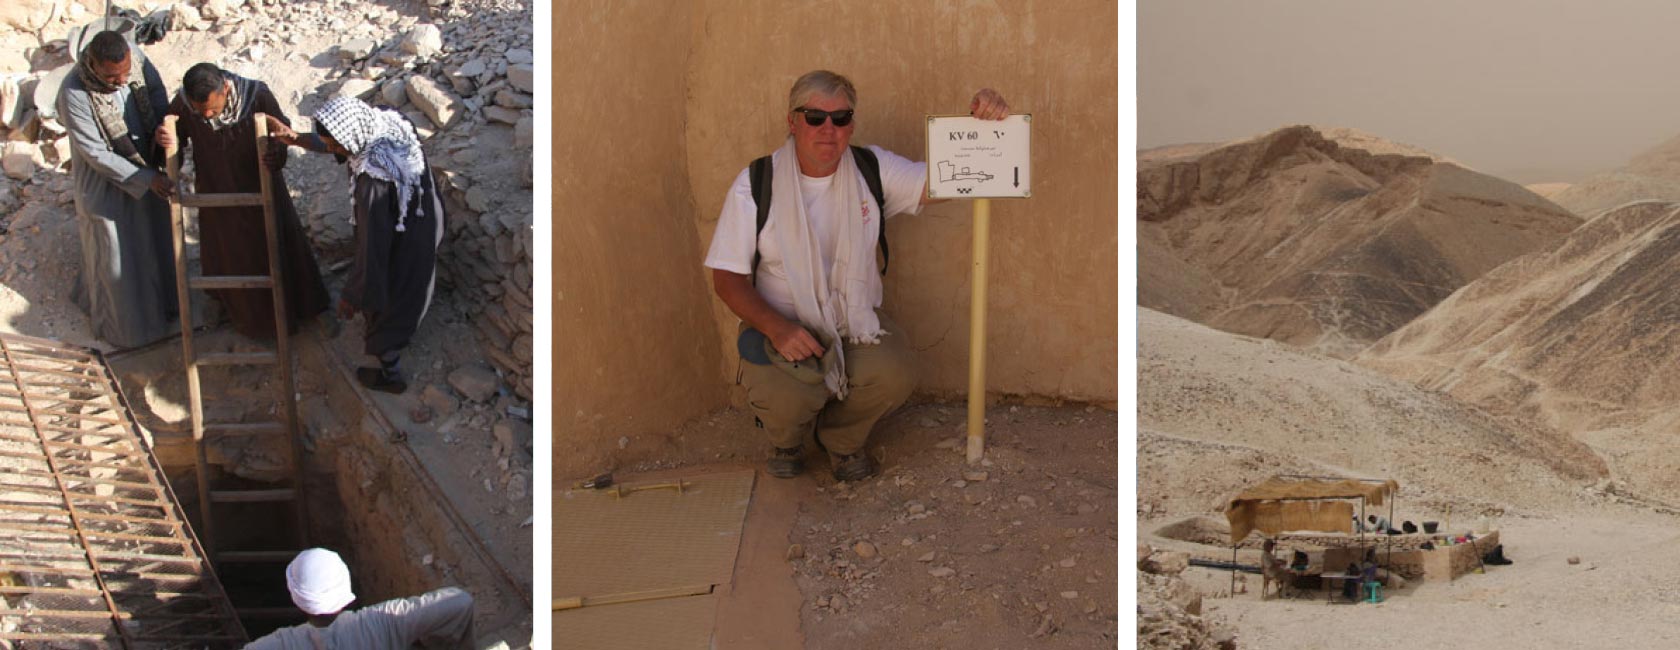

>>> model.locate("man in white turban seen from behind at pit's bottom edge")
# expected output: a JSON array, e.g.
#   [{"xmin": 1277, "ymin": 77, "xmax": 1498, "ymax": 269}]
[{"xmin": 245, "ymin": 549, "xmax": 472, "ymax": 650}]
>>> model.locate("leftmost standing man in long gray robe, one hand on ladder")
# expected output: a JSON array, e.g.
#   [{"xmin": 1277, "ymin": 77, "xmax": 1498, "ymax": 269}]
[{"xmin": 57, "ymin": 32, "xmax": 178, "ymax": 348}]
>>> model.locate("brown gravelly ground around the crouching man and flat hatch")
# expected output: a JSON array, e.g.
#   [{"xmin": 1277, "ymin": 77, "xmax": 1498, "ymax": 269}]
[{"xmin": 556, "ymin": 403, "xmax": 1119, "ymax": 648}]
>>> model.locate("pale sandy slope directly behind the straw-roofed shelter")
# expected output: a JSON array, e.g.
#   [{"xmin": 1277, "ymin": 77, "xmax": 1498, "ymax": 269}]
[{"xmin": 1137, "ymin": 309, "xmax": 1604, "ymax": 529}]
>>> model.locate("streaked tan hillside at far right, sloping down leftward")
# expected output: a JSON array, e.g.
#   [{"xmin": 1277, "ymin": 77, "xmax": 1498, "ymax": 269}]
[{"xmin": 1357, "ymin": 202, "xmax": 1680, "ymax": 504}]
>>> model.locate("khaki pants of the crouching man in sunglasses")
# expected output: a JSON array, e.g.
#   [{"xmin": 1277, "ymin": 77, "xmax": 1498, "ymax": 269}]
[{"xmin": 741, "ymin": 311, "xmax": 916, "ymax": 455}]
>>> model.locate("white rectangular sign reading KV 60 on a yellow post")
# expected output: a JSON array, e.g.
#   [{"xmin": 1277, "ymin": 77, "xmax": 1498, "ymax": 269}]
[{"xmin": 927, "ymin": 114, "xmax": 1033, "ymax": 198}]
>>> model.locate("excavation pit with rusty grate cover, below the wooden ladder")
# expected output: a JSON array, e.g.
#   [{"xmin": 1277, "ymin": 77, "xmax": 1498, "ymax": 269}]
[{"xmin": 0, "ymin": 333, "xmax": 531, "ymax": 648}]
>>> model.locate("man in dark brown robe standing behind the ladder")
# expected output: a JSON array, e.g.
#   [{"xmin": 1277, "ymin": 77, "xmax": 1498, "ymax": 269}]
[{"xmin": 160, "ymin": 64, "xmax": 331, "ymax": 339}]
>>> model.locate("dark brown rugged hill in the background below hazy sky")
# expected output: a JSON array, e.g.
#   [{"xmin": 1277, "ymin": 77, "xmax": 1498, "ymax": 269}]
[{"xmin": 1137, "ymin": 126, "xmax": 1579, "ymax": 356}]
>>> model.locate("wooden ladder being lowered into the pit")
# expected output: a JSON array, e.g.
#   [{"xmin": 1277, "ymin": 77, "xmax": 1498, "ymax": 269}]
[{"xmin": 163, "ymin": 113, "xmax": 309, "ymax": 594}]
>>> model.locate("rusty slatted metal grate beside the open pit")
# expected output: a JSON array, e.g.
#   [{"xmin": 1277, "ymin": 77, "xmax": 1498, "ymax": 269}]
[{"xmin": 0, "ymin": 334, "xmax": 245, "ymax": 650}]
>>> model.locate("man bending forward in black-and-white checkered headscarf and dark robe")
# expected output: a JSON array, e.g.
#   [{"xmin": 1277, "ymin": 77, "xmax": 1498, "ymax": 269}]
[{"xmin": 269, "ymin": 97, "xmax": 444, "ymax": 393}]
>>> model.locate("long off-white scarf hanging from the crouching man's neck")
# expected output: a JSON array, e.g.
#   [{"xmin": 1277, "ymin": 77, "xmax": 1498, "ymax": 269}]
[{"xmin": 769, "ymin": 136, "xmax": 885, "ymax": 400}]
